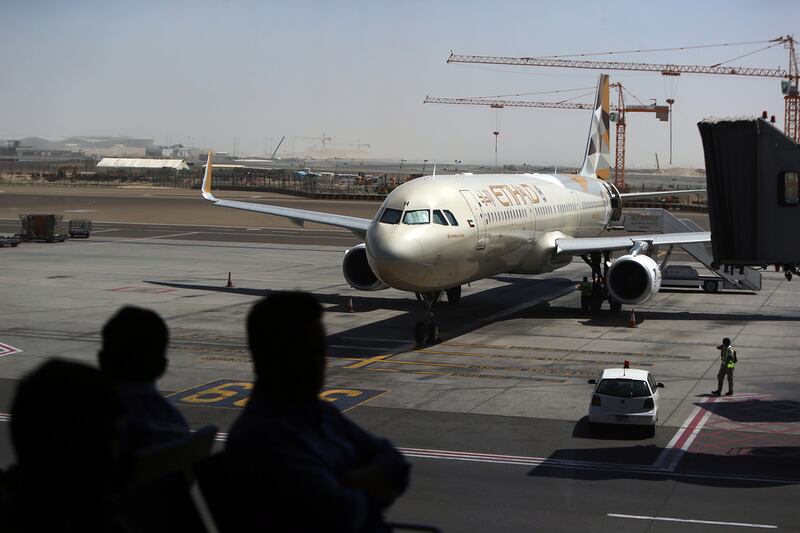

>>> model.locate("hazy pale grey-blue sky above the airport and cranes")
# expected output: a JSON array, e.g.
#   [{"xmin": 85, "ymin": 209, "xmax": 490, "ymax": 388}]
[{"xmin": 0, "ymin": 0, "xmax": 800, "ymax": 167}]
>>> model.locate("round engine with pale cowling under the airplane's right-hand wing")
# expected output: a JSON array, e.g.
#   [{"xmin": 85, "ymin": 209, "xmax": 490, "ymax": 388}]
[{"xmin": 606, "ymin": 255, "xmax": 661, "ymax": 305}]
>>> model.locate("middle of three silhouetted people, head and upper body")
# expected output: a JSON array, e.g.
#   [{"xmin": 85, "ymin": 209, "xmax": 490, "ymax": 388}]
[{"xmin": 98, "ymin": 306, "xmax": 189, "ymax": 450}]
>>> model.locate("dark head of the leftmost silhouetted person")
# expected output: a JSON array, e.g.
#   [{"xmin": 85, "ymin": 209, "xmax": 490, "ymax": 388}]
[{"xmin": 11, "ymin": 359, "xmax": 125, "ymax": 492}]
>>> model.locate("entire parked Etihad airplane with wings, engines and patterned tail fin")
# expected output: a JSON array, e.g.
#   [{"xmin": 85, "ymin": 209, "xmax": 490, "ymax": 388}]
[{"xmin": 202, "ymin": 74, "xmax": 711, "ymax": 345}]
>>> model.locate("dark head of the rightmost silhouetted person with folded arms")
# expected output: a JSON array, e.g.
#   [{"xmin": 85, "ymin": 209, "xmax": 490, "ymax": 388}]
[{"xmin": 247, "ymin": 292, "xmax": 326, "ymax": 401}]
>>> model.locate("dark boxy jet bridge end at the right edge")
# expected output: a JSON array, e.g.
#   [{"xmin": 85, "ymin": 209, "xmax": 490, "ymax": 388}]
[{"xmin": 698, "ymin": 118, "xmax": 800, "ymax": 279}]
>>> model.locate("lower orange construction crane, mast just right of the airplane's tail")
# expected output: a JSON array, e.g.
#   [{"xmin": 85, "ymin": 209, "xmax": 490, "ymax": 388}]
[{"xmin": 422, "ymin": 82, "xmax": 669, "ymax": 191}]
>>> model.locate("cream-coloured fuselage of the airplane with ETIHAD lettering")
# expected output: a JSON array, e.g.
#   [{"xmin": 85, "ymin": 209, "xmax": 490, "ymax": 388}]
[{"xmin": 366, "ymin": 174, "xmax": 613, "ymax": 292}]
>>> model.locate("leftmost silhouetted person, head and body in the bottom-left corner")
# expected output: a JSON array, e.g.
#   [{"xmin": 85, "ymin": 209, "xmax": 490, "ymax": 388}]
[{"xmin": 0, "ymin": 359, "xmax": 128, "ymax": 532}]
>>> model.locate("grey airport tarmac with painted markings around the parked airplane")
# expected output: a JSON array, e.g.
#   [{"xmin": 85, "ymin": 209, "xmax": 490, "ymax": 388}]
[{"xmin": 0, "ymin": 187, "xmax": 800, "ymax": 532}]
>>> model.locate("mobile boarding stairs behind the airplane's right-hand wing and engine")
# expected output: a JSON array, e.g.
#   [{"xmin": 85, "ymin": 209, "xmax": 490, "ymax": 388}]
[{"xmin": 623, "ymin": 208, "xmax": 761, "ymax": 291}]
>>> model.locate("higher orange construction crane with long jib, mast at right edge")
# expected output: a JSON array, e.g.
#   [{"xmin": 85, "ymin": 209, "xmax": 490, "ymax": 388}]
[{"xmin": 447, "ymin": 35, "xmax": 800, "ymax": 143}]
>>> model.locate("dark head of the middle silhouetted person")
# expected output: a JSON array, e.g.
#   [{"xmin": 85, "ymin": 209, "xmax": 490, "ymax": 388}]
[{"xmin": 98, "ymin": 306, "xmax": 169, "ymax": 383}]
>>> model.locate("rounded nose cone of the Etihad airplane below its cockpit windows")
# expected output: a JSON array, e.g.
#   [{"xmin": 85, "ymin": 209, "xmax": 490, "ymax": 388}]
[{"xmin": 366, "ymin": 227, "xmax": 430, "ymax": 292}]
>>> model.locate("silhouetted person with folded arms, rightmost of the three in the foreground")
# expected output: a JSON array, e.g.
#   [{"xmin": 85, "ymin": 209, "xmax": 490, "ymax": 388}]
[{"xmin": 225, "ymin": 292, "xmax": 410, "ymax": 532}]
